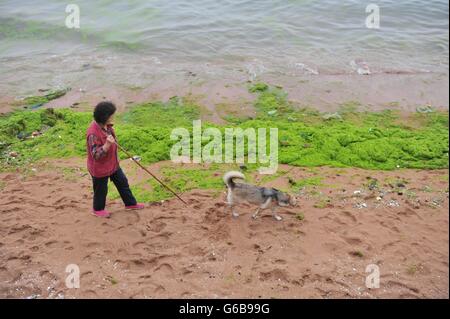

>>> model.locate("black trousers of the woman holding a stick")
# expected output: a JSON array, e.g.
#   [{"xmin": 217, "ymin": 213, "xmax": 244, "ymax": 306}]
[{"xmin": 92, "ymin": 167, "xmax": 137, "ymax": 211}]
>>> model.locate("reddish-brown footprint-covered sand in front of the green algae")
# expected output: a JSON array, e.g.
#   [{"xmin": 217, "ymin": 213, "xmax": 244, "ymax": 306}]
[{"xmin": 0, "ymin": 159, "xmax": 449, "ymax": 298}]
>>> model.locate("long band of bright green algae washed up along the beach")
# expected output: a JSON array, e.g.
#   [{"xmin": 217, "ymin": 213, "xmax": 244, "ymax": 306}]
[{"xmin": 0, "ymin": 85, "xmax": 448, "ymax": 176}]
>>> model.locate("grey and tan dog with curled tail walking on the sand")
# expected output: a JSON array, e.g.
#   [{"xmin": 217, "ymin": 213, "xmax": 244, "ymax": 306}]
[{"xmin": 223, "ymin": 171, "xmax": 296, "ymax": 221}]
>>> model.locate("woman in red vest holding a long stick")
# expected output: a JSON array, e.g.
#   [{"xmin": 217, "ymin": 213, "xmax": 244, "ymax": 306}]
[{"xmin": 86, "ymin": 102, "xmax": 144, "ymax": 217}]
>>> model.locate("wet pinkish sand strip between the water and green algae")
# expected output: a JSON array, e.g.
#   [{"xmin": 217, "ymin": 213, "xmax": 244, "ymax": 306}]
[{"xmin": 0, "ymin": 72, "xmax": 449, "ymax": 120}]
